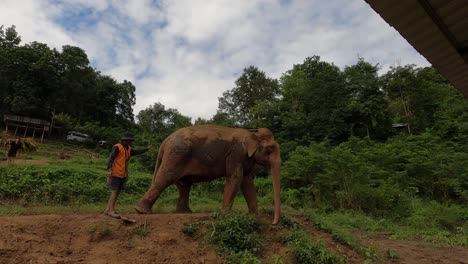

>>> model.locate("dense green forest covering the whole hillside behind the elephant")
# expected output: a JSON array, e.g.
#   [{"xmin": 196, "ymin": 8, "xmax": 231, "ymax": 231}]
[{"xmin": 0, "ymin": 23, "xmax": 468, "ymax": 232}]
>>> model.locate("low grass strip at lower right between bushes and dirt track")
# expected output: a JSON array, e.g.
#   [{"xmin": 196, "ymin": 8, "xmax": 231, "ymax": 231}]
[{"xmin": 305, "ymin": 208, "xmax": 468, "ymax": 248}]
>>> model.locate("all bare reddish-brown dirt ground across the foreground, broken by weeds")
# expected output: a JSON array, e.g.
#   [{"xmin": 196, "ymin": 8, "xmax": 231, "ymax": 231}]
[{"xmin": 0, "ymin": 213, "xmax": 468, "ymax": 263}]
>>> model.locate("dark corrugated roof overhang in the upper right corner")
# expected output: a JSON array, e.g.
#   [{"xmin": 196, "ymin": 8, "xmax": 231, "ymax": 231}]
[{"xmin": 365, "ymin": 0, "xmax": 468, "ymax": 96}]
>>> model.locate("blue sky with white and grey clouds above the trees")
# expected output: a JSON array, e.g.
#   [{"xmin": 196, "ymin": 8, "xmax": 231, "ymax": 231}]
[{"xmin": 0, "ymin": 0, "xmax": 430, "ymax": 121}]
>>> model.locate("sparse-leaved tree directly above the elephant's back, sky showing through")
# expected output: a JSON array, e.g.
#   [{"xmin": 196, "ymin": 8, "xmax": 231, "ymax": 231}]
[{"xmin": 218, "ymin": 66, "xmax": 279, "ymax": 127}]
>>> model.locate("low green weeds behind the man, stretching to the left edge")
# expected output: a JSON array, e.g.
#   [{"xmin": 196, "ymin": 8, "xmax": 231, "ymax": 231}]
[{"xmin": 0, "ymin": 166, "xmax": 151, "ymax": 204}]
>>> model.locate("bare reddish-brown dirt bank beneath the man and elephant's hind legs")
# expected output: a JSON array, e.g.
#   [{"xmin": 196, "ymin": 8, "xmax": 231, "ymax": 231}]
[{"xmin": 0, "ymin": 214, "xmax": 223, "ymax": 263}]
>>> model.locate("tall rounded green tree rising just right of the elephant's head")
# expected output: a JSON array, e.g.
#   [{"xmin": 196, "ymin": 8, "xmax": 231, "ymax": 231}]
[{"xmin": 280, "ymin": 56, "xmax": 350, "ymax": 145}]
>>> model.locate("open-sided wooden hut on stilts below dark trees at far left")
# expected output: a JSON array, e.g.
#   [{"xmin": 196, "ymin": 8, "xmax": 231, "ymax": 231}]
[{"xmin": 3, "ymin": 114, "xmax": 50, "ymax": 143}]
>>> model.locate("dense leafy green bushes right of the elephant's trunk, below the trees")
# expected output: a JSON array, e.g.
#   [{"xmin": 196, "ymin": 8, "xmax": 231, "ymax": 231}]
[{"xmin": 282, "ymin": 133, "xmax": 468, "ymax": 219}]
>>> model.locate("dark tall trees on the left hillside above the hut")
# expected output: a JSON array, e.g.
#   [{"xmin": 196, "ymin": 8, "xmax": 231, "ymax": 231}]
[{"xmin": 0, "ymin": 26, "xmax": 135, "ymax": 128}]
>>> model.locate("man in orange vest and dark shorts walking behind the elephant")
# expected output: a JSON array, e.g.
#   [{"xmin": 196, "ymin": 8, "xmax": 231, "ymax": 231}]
[{"xmin": 104, "ymin": 132, "xmax": 154, "ymax": 218}]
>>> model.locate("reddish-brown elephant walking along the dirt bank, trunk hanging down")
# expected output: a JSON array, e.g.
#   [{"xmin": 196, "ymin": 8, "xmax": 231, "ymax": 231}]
[{"xmin": 135, "ymin": 125, "xmax": 281, "ymax": 224}]
